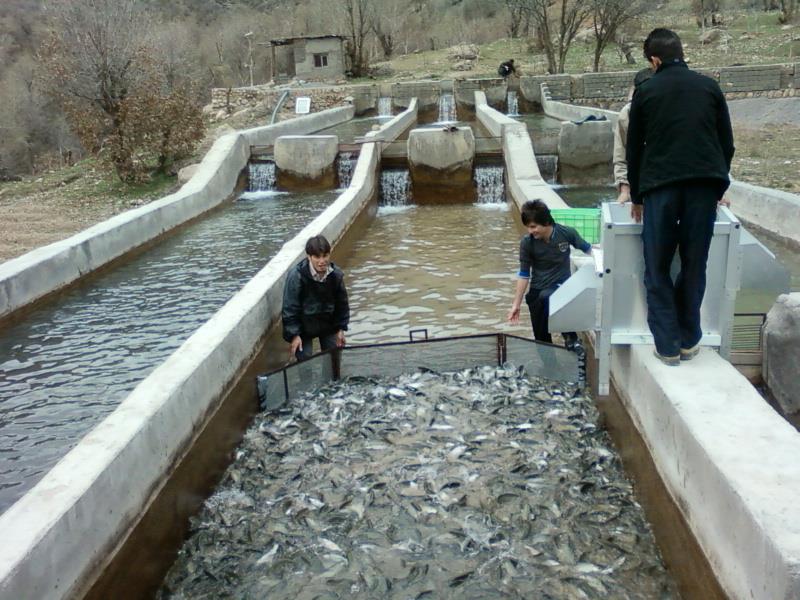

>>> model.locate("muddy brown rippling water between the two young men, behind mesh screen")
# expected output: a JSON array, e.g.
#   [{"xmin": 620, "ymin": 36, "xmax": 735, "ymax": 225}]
[{"xmin": 342, "ymin": 204, "xmax": 531, "ymax": 343}]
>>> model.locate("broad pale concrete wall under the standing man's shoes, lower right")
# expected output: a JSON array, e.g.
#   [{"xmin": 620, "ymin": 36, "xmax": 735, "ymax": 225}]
[{"xmin": 611, "ymin": 346, "xmax": 800, "ymax": 600}]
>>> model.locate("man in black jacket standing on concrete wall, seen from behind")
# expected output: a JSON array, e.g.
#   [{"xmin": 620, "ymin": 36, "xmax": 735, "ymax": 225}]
[{"xmin": 626, "ymin": 28, "xmax": 734, "ymax": 366}]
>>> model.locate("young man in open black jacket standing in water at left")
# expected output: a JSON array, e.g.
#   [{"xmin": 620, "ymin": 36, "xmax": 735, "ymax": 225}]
[{"xmin": 281, "ymin": 235, "xmax": 350, "ymax": 360}]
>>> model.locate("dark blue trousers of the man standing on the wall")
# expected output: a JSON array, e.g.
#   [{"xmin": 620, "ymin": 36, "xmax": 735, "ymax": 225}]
[{"xmin": 642, "ymin": 181, "xmax": 720, "ymax": 356}]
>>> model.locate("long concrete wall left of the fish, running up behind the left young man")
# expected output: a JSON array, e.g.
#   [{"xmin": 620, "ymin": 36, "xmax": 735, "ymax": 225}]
[{"xmin": 0, "ymin": 103, "xmax": 418, "ymax": 600}]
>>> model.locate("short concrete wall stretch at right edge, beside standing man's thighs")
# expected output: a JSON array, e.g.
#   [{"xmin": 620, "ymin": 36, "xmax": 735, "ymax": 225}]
[{"xmin": 725, "ymin": 181, "xmax": 800, "ymax": 247}]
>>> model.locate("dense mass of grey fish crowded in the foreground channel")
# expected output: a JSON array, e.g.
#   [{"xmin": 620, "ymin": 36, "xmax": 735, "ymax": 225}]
[{"xmin": 156, "ymin": 364, "xmax": 679, "ymax": 600}]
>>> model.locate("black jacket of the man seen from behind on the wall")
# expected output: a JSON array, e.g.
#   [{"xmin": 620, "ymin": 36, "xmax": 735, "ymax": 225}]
[{"xmin": 626, "ymin": 61, "xmax": 734, "ymax": 204}]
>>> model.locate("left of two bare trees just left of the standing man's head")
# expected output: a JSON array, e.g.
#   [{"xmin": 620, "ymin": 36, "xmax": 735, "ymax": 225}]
[{"xmin": 509, "ymin": 0, "xmax": 592, "ymax": 73}]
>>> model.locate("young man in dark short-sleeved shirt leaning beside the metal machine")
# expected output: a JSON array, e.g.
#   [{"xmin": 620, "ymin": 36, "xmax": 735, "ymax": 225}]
[{"xmin": 508, "ymin": 200, "xmax": 592, "ymax": 350}]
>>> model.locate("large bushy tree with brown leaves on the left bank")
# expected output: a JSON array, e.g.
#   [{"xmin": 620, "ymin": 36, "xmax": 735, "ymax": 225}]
[{"xmin": 40, "ymin": 0, "xmax": 202, "ymax": 181}]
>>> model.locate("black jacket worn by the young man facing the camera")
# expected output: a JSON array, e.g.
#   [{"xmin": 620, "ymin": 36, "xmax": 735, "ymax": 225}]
[{"xmin": 281, "ymin": 258, "xmax": 350, "ymax": 342}]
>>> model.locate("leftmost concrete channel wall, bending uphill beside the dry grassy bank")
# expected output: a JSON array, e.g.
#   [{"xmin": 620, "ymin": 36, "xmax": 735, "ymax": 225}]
[{"xmin": 0, "ymin": 107, "xmax": 353, "ymax": 318}]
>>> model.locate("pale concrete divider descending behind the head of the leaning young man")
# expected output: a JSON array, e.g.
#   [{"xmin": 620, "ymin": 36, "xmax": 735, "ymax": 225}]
[{"xmin": 475, "ymin": 92, "xmax": 569, "ymax": 208}]
